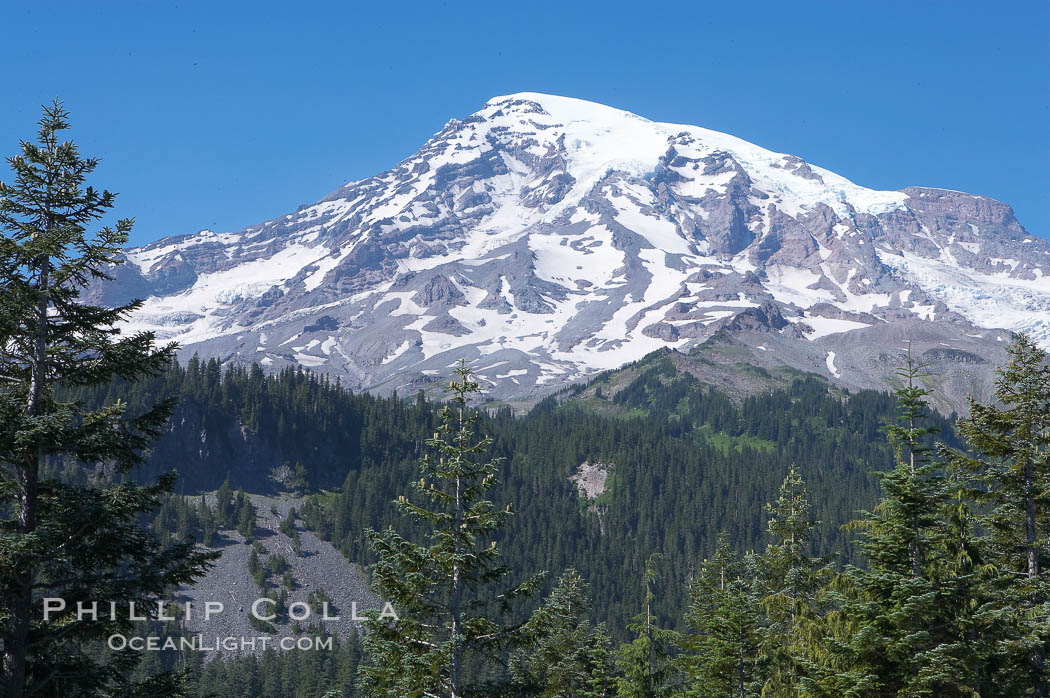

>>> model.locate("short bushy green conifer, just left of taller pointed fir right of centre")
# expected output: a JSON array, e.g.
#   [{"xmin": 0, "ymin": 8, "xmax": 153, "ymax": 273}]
[{"xmin": 684, "ymin": 533, "xmax": 763, "ymax": 698}]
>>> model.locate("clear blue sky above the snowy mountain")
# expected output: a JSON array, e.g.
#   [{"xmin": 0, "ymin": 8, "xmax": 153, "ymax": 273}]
[{"xmin": 6, "ymin": 0, "xmax": 1050, "ymax": 244}]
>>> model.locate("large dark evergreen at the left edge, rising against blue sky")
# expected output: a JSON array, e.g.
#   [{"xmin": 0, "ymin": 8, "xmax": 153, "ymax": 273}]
[{"xmin": 0, "ymin": 102, "xmax": 215, "ymax": 698}]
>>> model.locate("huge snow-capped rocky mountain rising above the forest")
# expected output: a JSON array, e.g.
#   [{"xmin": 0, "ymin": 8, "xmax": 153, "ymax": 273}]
[{"xmin": 95, "ymin": 92, "xmax": 1050, "ymax": 409}]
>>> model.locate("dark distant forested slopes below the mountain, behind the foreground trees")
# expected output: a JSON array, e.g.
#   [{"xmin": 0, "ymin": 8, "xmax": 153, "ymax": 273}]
[{"xmin": 71, "ymin": 348, "xmax": 950, "ymax": 635}]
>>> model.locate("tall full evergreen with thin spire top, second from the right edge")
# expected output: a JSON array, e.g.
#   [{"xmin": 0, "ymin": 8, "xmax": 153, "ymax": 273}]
[{"xmin": 811, "ymin": 347, "xmax": 981, "ymax": 696}]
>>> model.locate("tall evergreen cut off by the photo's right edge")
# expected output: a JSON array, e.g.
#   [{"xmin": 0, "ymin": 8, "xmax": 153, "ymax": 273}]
[{"xmin": 948, "ymin": 335, "xmax": 1050, "ymax": 696}]
